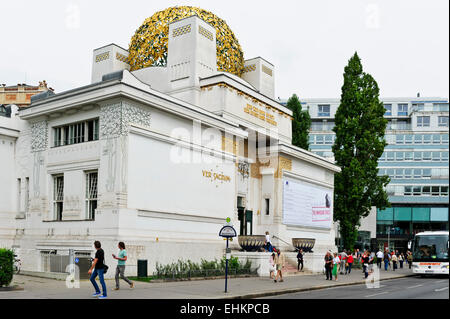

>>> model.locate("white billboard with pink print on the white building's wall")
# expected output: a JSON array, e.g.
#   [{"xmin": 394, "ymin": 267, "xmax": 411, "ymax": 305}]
[{"xmin": 283, "ymin": 177, "xmax": 333, "ymax": 228}]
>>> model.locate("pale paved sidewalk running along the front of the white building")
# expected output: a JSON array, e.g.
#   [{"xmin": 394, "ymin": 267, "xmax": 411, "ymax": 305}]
[{"xmin": 0, "ymin": 268, "xmax": 413, "ymax": 299}]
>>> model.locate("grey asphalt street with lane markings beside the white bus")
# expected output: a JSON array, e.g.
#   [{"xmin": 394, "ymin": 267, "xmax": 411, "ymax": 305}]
[{"xmin": 263, "ymin": 276, "xmax": 449, "ymax": 299}]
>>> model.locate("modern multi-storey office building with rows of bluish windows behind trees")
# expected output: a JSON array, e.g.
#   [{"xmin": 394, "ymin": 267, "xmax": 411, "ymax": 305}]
[{"xmin": 283, "ymin": 97, "xmax": 449, "ymax": 249}]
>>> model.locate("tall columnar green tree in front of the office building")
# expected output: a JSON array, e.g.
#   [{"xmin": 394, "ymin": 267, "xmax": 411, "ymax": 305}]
[{"xmin": 332, "ymin": 52, "xmax": 390, "ymax": 249}]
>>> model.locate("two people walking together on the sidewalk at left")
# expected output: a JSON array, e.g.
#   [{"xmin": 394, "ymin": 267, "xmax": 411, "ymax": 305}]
[{"xmin": 88, "ymin": 241, "xmax": 134, "ymax": 299}]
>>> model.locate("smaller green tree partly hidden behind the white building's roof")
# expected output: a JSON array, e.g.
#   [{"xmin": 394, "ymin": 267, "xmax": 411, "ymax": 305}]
[{"xmin": 286, "ymin": 94, "xmax": 311, "ymax": 150}]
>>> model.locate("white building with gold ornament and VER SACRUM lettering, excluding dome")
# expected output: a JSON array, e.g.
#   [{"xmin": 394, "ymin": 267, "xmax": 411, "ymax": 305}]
[{"xmin": 0, "ymin": 16, "xmax": 339, "ymax": 276}]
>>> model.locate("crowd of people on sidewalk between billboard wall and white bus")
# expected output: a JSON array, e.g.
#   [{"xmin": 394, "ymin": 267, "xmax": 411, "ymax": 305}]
[{"xmin": 324, "ymin": 249, "xmax": 412, "ymax": 280}]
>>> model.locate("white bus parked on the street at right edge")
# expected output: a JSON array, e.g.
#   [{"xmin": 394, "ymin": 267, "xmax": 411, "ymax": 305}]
[{"xmin": 408, "ymin": 231, "xmax": 449, "ymax": 275}]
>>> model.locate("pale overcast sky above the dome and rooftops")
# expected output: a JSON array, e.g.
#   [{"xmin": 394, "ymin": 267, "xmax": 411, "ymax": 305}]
[{"xmin": 0, "ymin": 0, "xmax": 449, "ymax": 99}]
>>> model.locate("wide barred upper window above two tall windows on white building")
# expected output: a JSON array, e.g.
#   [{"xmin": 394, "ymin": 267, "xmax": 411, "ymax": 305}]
[{"xmin": 53, "ymin": 119, "xmax": 99, "ymax": 146}]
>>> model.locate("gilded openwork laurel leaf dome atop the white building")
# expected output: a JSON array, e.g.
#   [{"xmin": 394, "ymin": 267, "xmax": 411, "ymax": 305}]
[{"xmin": 128, "ymin": 6, "xmax": 244, "ymax": 76}]
